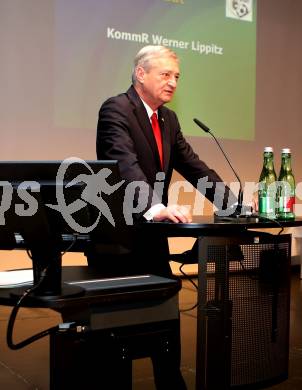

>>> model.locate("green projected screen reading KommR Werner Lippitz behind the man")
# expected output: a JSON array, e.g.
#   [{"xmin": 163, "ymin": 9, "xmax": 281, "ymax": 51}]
[{"xmin": 54, "ymin": 0, "xmax": 256, "ymax": 140}]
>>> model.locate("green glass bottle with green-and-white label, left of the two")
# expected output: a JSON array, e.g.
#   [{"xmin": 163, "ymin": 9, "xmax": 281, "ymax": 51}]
[{"xmin": 258, "ymin": 146, "xmax": 277, "ymax": 219}]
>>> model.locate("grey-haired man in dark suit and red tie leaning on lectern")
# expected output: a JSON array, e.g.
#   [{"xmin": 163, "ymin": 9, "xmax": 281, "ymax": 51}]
[{"xmin": 91, "ymin": 46, "xmax": 236, "ymax": 389}]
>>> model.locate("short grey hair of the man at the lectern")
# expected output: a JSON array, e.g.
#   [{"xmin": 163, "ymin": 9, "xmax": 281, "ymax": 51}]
[{"xmin": 132, "ymin": 45, "xmax": 178, "ymax": 85}]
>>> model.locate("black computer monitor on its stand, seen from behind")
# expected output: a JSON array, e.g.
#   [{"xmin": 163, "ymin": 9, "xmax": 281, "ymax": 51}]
[{"xmin": 0, "ymin": 158, "xmax": 125, "ymax": 299}]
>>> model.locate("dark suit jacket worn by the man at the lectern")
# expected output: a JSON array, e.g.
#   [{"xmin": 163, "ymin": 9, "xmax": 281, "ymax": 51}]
[{"xmin": 96, "ymin": 86, "xmax": 236, "ymax": 276}]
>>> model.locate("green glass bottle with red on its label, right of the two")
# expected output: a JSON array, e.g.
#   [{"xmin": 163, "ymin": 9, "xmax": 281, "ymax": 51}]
[{"xmin": 277, "ymin": 148, "xmax": 296, "ymax": 220}]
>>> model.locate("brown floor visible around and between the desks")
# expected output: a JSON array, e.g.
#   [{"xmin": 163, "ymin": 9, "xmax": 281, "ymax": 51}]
[{"xmin": 0, "ymin": 270, "xmax": 302, "ymax": 390}]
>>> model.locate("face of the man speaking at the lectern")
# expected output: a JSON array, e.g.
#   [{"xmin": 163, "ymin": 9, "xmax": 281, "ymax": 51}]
[{"xmin": 137, "ymin": 57, "xmax": 179, "ymax": 110}]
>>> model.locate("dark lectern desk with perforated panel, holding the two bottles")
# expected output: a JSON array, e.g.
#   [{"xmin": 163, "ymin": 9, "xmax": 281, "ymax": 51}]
[{"xmin": 144, "ymin": 217, "xmax": 302, "ymax": 390}]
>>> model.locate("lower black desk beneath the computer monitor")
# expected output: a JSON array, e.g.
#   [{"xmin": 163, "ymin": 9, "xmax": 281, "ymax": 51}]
[{"xmin": 0, "ymin": 266, "xmax": 181, "ymax": 390}]
